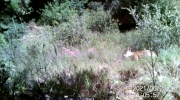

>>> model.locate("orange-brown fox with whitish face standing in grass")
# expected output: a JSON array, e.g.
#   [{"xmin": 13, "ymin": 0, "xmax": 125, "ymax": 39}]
[{"xmin": 124, "ymin": 48, "xmax": 157, "ymax": 61}]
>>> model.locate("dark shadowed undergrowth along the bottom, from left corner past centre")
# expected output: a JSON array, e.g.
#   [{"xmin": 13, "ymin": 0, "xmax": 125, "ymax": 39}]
[{"xmin": 0, "ymin": 67, "xmax": 112, "ymax": 100}]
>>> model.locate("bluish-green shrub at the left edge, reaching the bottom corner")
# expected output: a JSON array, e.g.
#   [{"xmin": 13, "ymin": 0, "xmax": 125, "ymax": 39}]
[{"xmin": 0, "ymin": 41, "xmax": 29, "ymax": 100}]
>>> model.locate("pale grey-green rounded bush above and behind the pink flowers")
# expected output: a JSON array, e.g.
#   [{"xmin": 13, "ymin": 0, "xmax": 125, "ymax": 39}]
[{"xmin": 48, "ymin": 11, "xmax": 89, "ymax": 45}]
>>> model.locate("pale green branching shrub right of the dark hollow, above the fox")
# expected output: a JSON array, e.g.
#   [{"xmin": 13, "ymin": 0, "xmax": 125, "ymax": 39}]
[{"xmin": 126, "ymin": 0, "xmax": 180, "ymax": 51}]
